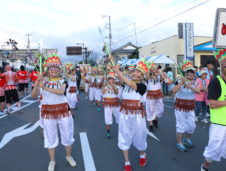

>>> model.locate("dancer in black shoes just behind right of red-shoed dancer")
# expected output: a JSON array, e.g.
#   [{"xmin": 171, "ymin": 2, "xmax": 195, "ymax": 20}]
[{"xmin": 146, "ymin": 63, "xmax": 166, "ymax": 132}]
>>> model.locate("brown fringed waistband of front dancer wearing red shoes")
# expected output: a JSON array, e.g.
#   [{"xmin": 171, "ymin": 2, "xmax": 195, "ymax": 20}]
[{"xmin": 120, "ymin": 99, "xmax": 145, "ymax": 117}]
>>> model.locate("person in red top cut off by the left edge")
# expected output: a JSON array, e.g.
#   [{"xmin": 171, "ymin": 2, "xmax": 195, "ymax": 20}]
[{"xmin": 0, "ymin": 67, "xmax": 6, "ymax": 115}]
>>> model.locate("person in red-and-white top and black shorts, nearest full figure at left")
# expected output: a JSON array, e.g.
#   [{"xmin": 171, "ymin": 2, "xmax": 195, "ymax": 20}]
[{"xmin": 1, "ymin": 64, "xmax": 22, "ymax": 114}]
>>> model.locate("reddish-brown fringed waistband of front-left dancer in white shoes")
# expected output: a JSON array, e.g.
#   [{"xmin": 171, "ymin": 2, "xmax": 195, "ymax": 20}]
[{"xmin": 41, "ymin": 103, "xmax": 71, "ymax": 119}]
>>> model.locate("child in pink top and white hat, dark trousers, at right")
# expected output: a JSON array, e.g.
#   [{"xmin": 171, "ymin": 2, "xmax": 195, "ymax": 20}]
[{"xmin": 195, "ymin": 70, "xmax": 209, "ymax": 123}]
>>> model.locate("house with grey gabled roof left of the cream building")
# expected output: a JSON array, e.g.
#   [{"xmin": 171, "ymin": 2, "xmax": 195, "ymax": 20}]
[{"xmin": 111, "ymin": 42, "xmax": 138, "ymax": 61}]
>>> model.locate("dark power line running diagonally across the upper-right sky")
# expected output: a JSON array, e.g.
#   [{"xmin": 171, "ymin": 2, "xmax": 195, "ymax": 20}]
[{"xmin": 114, "ymin": 0, "xmax": 210, "ymax": 43}]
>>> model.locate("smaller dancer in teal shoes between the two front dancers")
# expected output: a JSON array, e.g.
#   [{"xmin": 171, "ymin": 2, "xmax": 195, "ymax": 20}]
[{"xmin": 102, "ymin": 71, "xmax": 120, "ymax": 139}]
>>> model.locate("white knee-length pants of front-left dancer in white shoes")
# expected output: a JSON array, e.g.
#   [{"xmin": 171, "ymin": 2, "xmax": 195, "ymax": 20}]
[{"xmin": 42, "ymin": 116, "xmax": 74, "ymax": 148}]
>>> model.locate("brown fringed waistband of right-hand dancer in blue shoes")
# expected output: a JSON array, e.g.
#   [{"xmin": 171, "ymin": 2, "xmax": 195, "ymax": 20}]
[{"xmin": 174, "ymin": 98, "xmax": 195, "ymax": 112}]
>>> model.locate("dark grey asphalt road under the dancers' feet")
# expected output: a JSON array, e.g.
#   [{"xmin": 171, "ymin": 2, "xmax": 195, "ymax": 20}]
[{"xmin": 0, "ymin": 93, "xmax": 226, "ymax": 171}]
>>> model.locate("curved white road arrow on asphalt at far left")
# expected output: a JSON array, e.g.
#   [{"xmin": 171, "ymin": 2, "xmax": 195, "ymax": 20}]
[{"xmin": 0, "ymin": 121, "xmax": 39, "ymax": 149}]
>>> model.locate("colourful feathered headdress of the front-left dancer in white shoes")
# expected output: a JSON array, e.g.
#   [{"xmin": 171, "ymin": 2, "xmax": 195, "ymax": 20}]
[{"xmin": 43, "ymin": 53, "xmax": 62, "ymax": 70}]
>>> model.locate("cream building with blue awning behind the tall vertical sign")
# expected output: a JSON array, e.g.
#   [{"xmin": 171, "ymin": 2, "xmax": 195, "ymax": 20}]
[{"xmin": 139, "ymin": 35, "xmax": 218, "ymax": 69}]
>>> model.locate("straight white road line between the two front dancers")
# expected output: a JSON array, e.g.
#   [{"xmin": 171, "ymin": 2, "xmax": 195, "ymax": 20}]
[{"xmin": 80, "ymin": 132, "xmax": 96, "ymax": 171}]
